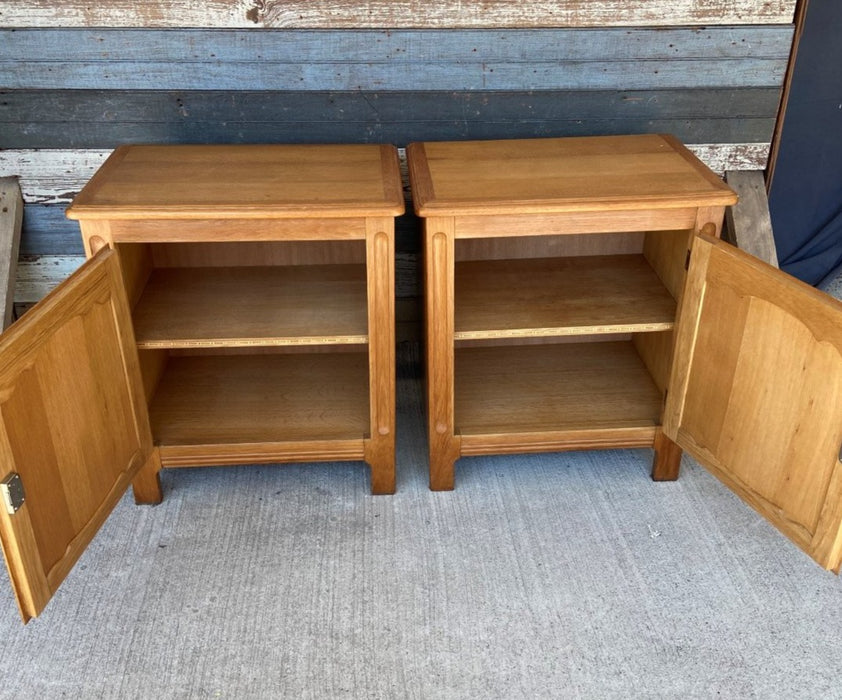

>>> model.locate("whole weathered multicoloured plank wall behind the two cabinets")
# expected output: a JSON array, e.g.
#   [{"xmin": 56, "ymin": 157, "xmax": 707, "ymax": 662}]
[{"xmin": 0, "ymin": 0, "xmax": 795, "ymax": 318}]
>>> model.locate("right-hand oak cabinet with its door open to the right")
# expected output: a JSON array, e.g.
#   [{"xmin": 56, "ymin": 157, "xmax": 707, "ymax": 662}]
[{"xmin": 408, "ymin": 135, "xmax": 842, "ymax": 572}]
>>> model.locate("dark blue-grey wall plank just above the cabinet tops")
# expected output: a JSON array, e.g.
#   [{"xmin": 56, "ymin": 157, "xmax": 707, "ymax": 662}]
[{"xmin": 0, "ymin": 87, "xmax": 780, "ymax": 148}]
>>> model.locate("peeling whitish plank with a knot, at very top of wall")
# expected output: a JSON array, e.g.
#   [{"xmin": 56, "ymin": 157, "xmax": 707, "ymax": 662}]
[{"xmin": 0, "ymin": 0, "xmax": 795, "ymax": 29}]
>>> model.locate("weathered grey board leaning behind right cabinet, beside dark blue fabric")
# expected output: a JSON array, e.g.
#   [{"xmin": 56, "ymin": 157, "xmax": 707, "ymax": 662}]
[{"xmin": 725, "ymin": 170, "xmax": 778, "ymax": 267}]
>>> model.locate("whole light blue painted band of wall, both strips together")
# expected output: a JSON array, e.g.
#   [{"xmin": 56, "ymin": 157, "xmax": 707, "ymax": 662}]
[{"xmin": 0, "ymin": 27, "xmax": 791, "ymax": 91}]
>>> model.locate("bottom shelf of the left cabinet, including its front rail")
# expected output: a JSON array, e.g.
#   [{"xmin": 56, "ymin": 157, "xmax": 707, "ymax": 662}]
[{"xmin": 149, "ymin": 352, "xmax": 369, "ymax": 466}]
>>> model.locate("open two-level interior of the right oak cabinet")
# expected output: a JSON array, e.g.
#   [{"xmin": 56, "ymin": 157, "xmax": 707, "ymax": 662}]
[{"xmin": 454, "ymin": 230, "xmax": 691, "ymax": 438}]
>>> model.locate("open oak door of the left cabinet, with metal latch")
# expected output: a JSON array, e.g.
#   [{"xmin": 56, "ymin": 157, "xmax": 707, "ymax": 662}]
[{"xmin": 0, "ymin": 249, "xmax": 152, "ymax": 621}]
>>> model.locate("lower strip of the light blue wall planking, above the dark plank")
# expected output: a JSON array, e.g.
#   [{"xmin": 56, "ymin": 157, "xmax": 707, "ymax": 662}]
[{"xmin": 0, "ymin": 58, "xmax": 786, "ymax": 90}]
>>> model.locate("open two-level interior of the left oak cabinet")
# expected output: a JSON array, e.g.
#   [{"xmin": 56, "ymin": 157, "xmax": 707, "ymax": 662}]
[{"xmin": 116, "ymin": 240, "xmax": 370, "ymax": 456}]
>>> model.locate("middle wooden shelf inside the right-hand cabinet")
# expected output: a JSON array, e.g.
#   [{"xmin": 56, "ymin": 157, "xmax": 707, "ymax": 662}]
[{"xmin": 454, "ymin": 255, "xmax": 675, "ymax": 341}]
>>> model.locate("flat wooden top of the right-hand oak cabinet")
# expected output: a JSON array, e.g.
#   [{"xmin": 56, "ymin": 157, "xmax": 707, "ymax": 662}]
[{"xmin": 408, "ymin": 134, "xmax": 737, "ymax": 216}]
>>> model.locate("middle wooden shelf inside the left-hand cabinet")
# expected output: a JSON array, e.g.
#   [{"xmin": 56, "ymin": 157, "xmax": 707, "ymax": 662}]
[{"xmin": 133, "ymin": 265, "xmax": 368, "ymax": 349}]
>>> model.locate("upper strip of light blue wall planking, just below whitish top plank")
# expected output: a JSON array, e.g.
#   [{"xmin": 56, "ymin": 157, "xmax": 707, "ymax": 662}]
[{"xmin": 0, "ymin": 25, "xmax": 792, "ymax": 64}]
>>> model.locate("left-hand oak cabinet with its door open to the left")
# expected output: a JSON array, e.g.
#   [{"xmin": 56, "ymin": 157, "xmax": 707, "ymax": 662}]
[{"xmin": 0, "ymin": 145, "xmax": 404, "ymax": 620}]
